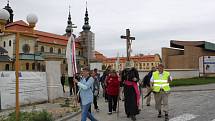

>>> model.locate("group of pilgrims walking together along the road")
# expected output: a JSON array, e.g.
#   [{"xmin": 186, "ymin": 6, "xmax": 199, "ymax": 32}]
[{"xmin": 62, "ymin": 63, "xmax": 172, "ymax": 121}]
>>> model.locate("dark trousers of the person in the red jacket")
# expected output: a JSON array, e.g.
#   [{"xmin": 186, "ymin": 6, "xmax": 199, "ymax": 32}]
[{"xmin": 108, "ymin": 95, "xmax": 118, "ymax": 112}]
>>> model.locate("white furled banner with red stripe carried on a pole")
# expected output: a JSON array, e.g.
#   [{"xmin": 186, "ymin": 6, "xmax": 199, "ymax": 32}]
[{"xmin": 66, "ymin": 34, "xmax": 77, "ymax": 77}]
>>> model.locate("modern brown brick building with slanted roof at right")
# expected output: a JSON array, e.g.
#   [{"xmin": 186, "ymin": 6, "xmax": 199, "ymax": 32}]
[{"xmin": 162, "ymin": 40, "xmax": 215, "ymax": 69}]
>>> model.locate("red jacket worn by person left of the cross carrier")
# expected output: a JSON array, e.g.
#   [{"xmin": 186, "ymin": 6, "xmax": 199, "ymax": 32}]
[{"xmin": 106, "ymin": 75, "xmax": 120, "ymax": 96}]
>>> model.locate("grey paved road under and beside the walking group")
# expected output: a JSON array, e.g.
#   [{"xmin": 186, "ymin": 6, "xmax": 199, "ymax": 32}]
[{"xmin": 69, "ymin": 86, "xmax": 215, "ymax": 121}]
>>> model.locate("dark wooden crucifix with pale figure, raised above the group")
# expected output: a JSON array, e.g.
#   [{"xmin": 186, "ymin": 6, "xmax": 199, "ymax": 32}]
[{"xmin": 121, "ymin": 29, "xmax": 135, "ymax": 61}]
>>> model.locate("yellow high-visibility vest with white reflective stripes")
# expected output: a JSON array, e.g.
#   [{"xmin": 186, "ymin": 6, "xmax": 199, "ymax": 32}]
[{"xmin": 152, "ymin": 71, "xmax": 170, "ymax": 92}]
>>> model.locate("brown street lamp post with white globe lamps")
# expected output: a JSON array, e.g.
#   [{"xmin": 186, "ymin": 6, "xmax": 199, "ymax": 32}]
[{"xmin": 0, "ymin": 9, "xmax": 38, "ymax": 121}]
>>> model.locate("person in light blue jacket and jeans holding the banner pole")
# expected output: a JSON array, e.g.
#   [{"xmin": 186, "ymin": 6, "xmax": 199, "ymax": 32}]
[{"xmin": 74, "ymin": 67, "xmax": 98, "ymax": 121}]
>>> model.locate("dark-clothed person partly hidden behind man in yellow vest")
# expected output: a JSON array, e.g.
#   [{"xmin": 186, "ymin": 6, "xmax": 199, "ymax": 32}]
[{"xmin": 142, "ymin": 67, "xmax": 156, "ymax": 106}]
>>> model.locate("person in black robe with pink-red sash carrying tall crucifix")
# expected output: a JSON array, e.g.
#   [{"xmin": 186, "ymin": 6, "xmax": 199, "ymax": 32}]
[{"xmin": 121, "ymin": 29, "xmax": 140, "ymax": 121}]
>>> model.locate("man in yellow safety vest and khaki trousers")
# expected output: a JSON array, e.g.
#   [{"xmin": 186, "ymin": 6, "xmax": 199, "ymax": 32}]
[{"xmin": 150, "ymin": 64, "xmax": 172, "ymax": 120}]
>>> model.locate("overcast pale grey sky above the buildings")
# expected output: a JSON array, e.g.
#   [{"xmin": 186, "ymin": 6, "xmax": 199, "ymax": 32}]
[{"xmin": 0, "ymin": 0, "xmax": 215, "ymax": 57}]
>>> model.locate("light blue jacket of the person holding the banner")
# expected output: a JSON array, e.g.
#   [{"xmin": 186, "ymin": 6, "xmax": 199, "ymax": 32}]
[{"xmin": 78, "ymin": 77, "xmax": 94, "ymax": 105}]
